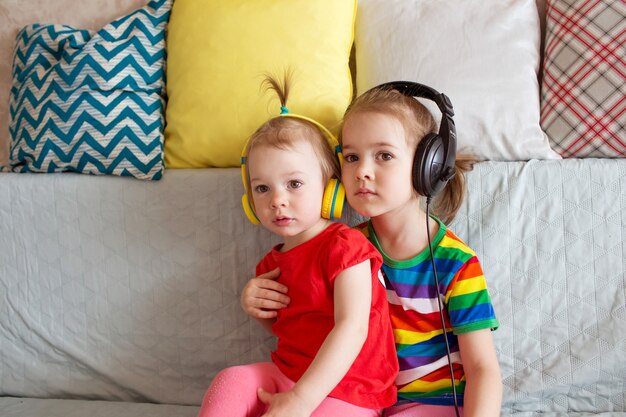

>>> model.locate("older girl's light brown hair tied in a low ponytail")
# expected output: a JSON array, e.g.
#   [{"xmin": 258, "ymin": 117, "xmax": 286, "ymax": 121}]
[{"xmin": 339, "ymin": 89, "xmax": 476, "ymax": 224}]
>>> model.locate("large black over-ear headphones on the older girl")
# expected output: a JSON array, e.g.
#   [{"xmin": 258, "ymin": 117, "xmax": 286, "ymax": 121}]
[{"xmin": 366, "ymin": 81, "xmax": 456, "ymax": 198}]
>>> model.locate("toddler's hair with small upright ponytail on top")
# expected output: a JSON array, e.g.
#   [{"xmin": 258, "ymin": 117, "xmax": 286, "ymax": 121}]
[{"xmin": 242, "ymin": 72, "xmax": 341, "ymax": 206}]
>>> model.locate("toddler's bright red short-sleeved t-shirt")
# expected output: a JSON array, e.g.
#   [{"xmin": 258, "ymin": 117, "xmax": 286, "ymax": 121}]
[{"xmin": 256, "ymin": 223, "xmax": 398, "ymax": 408}]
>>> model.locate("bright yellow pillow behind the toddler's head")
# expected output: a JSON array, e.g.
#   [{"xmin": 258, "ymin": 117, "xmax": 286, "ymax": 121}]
[{"xmin": 165, "ymin": 0, "xmax": 356, "ymax": 168}]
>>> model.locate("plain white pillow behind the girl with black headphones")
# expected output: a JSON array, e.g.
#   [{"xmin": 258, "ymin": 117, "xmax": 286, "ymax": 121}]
[{"xmin": 355, "ymin": 0, "xmax": 560, "ymax": 160}]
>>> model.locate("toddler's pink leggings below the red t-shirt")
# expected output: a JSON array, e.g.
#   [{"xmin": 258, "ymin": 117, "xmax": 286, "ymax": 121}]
[{"xmin": 198, "ymin": 362, "xmax": 381, "ymax": 417}]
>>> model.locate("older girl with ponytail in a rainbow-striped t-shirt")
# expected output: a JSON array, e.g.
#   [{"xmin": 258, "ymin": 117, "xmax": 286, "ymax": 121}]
[{"xmin": 242, "ymin": 82, "xmax": 502, "ymax": 417}]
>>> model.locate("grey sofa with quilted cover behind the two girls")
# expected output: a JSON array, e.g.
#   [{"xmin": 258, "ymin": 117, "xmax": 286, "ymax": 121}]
[{"xmin": 0, "ymin": 159, "xmax": 626, "ymax": 417}]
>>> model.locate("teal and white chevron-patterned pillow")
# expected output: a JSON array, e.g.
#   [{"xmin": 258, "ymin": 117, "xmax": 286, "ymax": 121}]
[{"xmin": 4, "ymin": 0, "xmax": 172, "ymax": 180}]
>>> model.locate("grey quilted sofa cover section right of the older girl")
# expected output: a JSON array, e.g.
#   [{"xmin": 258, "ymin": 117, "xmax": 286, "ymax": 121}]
[{"xmin": 451, "ymin": 159, "xmax": 626, "ymax": 417}]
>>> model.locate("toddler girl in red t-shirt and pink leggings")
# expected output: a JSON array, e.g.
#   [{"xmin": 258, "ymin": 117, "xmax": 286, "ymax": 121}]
[{"xmin": 199, "ymin": 75, "xmax": 398, "ymax": 417}]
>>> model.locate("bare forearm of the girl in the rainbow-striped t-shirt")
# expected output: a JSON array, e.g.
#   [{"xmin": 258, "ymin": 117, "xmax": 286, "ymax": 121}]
[{"xmin": 458, "ymin": 329, "xmax": 502, "ymax": 417}]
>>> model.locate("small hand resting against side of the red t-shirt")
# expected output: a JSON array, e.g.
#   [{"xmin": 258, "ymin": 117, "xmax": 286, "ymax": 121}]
[{"xmin": 241, "ymin": 268, "xmax": 290, "ymax": 319}]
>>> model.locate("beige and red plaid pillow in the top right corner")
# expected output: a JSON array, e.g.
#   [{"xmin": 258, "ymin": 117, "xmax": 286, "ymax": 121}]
[{"xmin": 541, "ymin": 0, "xmax": 626, "ymax": 157}]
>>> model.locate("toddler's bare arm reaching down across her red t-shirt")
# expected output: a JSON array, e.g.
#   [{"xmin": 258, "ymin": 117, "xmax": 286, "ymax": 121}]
[{"xmin": 259, "ymin": 260, "xmax": 372, "ymax": 417}]
